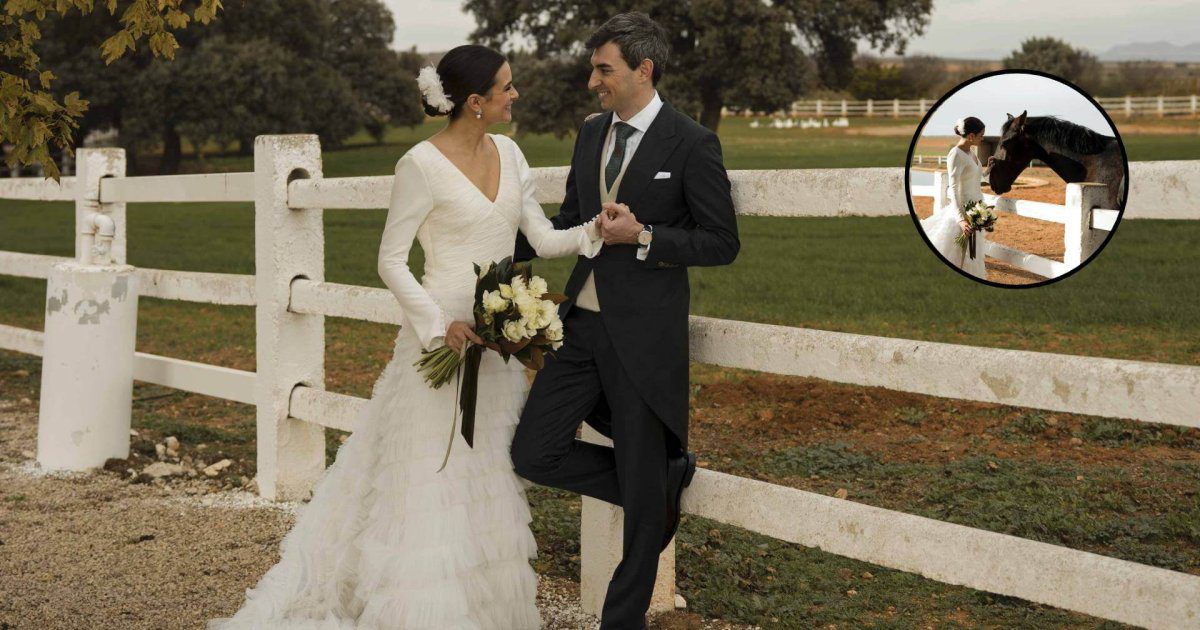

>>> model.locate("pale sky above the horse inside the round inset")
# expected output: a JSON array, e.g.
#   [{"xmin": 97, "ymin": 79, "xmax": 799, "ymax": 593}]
[{"xmin": 920, "ymin": 74, "xmax": 1116, "ymax": 136}]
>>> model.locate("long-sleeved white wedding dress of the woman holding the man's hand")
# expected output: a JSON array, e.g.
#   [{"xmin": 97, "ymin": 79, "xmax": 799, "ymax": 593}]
[{"xmin": 208, "ymin": 134, "xmax": 604, "ymax": 630}]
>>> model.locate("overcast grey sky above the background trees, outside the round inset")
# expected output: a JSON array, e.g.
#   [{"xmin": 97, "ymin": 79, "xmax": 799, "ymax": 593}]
[{"xmin": 384, "ymin": 0, "xmax": 1200, "ymax": 59}]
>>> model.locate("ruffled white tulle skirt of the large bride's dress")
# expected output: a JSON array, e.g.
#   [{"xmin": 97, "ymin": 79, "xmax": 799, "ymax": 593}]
[{"xmin": 208, "ymin": 330, "xmax": 541, "ymax": 630}]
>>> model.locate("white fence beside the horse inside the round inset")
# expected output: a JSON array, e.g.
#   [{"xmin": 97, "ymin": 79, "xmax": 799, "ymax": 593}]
[{"xmin": 910, "ymin": 170, "xmax": 1121, "ymax": 278}]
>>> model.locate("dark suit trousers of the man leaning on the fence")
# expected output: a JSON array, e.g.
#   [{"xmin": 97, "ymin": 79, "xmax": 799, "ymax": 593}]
[{"xmin": 511, "ymin": 308, "xmax": 670, "ymax": 630}]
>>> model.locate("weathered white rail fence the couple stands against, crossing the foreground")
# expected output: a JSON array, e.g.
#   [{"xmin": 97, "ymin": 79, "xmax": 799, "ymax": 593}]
[{"xmin": 0, "ymin": 134, "xmax": 1200, "ymax": 629}]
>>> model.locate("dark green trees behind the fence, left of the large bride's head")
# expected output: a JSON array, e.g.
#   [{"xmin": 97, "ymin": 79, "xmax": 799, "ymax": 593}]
[{"xmin": 35, "ymin": 0, "xmax": 424, "ymax": 173}]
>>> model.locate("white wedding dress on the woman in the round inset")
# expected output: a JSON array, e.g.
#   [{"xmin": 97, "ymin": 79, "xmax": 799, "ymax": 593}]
[{"xmin": 920, "ymin": 146, "xmax": 988, "ymax": 280}]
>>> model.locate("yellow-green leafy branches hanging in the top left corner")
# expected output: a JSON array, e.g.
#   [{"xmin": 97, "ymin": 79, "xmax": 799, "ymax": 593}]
[{"xmin": 0, "ymin": 0, "xmax": 222, "ymax": 181}]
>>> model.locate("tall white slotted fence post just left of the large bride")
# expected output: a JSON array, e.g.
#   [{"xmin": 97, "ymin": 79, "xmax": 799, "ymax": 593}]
[{"xmin": 254, "ymin": 133, "xmax": 325, "ymax": 500}]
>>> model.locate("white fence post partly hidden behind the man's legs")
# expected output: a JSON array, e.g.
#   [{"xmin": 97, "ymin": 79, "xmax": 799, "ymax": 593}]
[{"xmin": 580, "ymin": 424, "xmax": 676, "ymax": 617}]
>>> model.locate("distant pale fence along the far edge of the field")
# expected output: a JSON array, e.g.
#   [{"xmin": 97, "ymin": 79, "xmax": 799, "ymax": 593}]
[{"xmin": 725, "ymin": 95, "xmax": 1200, "ymax": 118}]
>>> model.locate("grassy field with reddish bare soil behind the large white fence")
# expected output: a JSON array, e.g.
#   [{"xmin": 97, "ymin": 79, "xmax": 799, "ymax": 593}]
[{"xmin": 0, "ymin": 119, "xmax": 1200, "ymax": 628}]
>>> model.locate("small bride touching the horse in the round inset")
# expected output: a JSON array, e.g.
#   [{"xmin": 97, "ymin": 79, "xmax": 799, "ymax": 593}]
[{"xmin": 920, "ymin": 116, "xmax": 995, "ymax": 280}]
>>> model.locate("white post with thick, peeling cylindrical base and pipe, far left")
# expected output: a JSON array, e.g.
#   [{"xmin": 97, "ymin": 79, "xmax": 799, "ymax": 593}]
[{"xmin": 37, "ymin": 148, "xmax": 138, "ymax": 470}]
